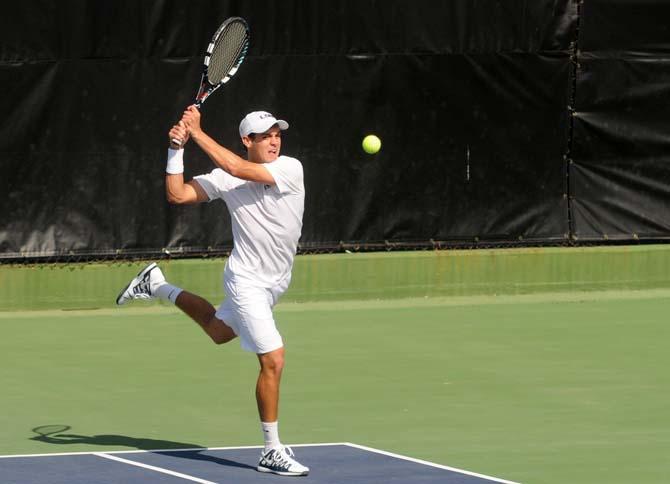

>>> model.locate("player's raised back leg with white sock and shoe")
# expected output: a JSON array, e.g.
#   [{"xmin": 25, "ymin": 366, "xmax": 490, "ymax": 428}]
[{"xmin": 116, "ymin": 263, "xmax": 235, "ymax": 344}]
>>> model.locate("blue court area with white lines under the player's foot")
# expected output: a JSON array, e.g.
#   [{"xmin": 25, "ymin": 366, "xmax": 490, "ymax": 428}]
[{"xmin": 0, "ymin": 443, "xmax": 514, "ymax": 484}]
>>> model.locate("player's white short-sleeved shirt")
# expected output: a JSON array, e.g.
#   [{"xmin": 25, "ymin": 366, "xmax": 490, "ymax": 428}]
[{"xmin": 194, "ymin": 156, "xmax": 305, "ymax": 288}]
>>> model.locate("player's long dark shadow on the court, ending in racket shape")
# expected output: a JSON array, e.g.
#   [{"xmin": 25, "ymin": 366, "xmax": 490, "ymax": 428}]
[{"xmin": 30, "ymin": 425, "xmax": 256, "ymax": 470}]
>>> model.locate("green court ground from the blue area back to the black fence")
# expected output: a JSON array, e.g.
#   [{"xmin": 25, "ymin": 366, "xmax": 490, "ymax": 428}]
[{"xmin": 0, "ymin": 247, "xmax": 670, "ymax": 483}]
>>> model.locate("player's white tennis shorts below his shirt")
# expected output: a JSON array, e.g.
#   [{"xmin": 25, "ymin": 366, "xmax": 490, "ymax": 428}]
[{"xmin": 216, "ymin": 277, "xmax": 291, "ymax": 354}]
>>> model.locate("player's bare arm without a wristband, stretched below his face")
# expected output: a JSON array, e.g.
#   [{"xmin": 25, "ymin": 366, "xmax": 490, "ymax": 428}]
[{"xmin": 182, "ymin": 106, "xmax": 275, "ymax": 185}]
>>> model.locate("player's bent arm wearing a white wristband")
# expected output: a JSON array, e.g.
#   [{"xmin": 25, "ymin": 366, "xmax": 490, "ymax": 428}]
[{"xmin": 165, "ymin": 121, "xmax": 209, "ymax": 205}]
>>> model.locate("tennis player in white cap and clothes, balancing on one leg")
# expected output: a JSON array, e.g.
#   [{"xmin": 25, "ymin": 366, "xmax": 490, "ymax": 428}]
[{"xmin": 116, "ymin": 106, "xmax": 309, "ymax": 476}]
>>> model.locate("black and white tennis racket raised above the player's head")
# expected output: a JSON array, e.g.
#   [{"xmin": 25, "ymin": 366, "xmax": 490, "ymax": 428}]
[{"xmin": 172, "ymin": 17, "xmax": 249, "ymax": 146}]
